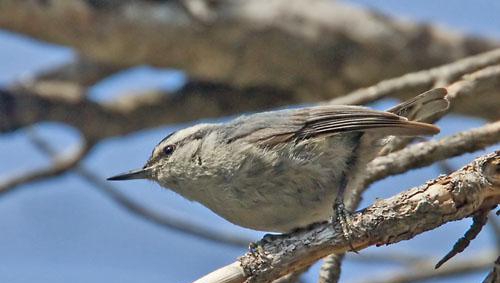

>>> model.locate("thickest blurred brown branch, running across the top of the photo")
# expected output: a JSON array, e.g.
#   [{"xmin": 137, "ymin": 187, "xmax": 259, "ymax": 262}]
[{"xmin": 0, "ymin": 0, "xmax": 498, "ymax": 102}]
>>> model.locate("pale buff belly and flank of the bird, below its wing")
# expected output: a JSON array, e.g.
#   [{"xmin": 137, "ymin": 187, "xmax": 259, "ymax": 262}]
[{"xmin": 170, "ymin": 137, "xmax": 358, "ymax": 232}]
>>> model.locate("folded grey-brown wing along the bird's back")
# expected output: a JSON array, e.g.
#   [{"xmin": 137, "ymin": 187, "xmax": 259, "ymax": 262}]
[{"xmin": 227, "ymin": 105, "xmax": 439, "ymax": 146}]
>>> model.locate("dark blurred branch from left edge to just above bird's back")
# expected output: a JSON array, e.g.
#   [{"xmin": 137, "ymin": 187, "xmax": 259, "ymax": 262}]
[{"xmin": 0, "ymin": 82, "xmax": 291, "ymax": 141}]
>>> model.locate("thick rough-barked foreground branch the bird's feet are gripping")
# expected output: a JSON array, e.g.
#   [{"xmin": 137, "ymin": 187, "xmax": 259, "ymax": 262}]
[{"xmin": 197, "ymin": 151, "xmax": 500, "ymax": 283}]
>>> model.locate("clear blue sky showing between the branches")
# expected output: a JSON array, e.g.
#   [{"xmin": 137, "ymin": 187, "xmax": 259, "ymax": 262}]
[{"xmin": 0, "ymin": 0, "xmax": 500, "ymax": 283}]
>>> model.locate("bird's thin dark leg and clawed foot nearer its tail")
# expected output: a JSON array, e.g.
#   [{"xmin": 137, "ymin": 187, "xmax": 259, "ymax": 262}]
[{"xmin": 331, "ymin": 174, "xmax": 357, "ymax": 253}]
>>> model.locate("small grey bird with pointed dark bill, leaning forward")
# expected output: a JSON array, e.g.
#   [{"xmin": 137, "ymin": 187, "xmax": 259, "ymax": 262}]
[{"xmin": 108, "ymin": 88, "xmax": 448, "ymax": 232}]
